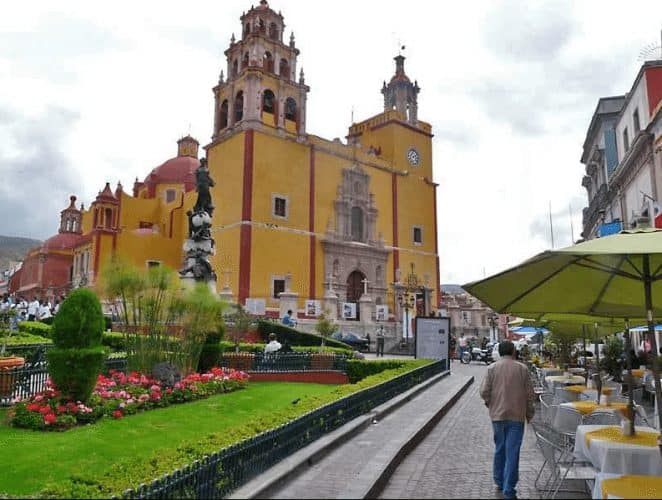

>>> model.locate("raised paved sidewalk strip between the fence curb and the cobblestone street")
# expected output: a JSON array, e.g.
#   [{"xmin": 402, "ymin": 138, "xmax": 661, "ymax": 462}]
[{"xmin": 260, "ymin": 374, "xmax": 471, "ymax": 498}]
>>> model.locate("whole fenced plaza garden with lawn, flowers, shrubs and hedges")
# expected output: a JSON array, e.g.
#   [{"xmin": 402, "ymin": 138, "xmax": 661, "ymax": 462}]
[{"xmin": 0, "ymin": 263, "xmax": 443, "ymax": 498}]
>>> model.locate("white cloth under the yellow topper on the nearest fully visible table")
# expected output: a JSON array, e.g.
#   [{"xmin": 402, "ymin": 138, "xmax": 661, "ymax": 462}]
[{"xmin": 575, "ymin": 425, "xmax": 662, "ymax": 476}]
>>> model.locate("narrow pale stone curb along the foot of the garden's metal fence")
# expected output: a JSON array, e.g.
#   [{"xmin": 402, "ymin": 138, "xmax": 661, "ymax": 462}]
[{"xmin": 231, "ymin": 371, "xmax": 454, "ymax": 499}]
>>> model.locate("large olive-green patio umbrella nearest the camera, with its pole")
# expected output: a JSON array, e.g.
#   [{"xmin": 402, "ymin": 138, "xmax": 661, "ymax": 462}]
[{"xmin": 462, "ymin": 228, "xmax": 662, "ymax": 436}]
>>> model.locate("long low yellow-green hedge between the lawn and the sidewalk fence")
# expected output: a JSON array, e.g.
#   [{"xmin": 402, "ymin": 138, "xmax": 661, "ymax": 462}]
[{"xmin": 37, "ymin": 359, "xmax": 432, "ymax": 498}]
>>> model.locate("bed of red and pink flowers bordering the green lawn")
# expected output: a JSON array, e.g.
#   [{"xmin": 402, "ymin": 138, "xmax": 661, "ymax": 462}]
[{"xmin": 8, "ymin": 368, "xmax": 248, "ymax": 430}]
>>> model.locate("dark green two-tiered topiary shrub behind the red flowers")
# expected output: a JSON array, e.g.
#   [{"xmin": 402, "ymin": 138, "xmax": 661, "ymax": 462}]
[{"xmin": 47, "ymin": 288, "xmax": 105, "ymax": 402}]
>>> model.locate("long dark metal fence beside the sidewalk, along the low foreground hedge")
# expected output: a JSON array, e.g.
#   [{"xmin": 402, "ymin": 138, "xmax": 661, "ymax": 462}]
[{"xmin": 122, "ymin": 360, "xmax": 447, "ymax": 499}]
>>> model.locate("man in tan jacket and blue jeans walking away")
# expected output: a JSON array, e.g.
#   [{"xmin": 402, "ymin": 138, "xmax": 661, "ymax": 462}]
[{"xmin": 480, "ymin": 340, "xmax": 535, "ymax": 498}]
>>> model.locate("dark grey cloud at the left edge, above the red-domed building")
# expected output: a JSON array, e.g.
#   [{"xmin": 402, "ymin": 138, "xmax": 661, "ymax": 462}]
[{"xmin": 0, "ymin": 107, "xmax": 80, "ymax": 239}]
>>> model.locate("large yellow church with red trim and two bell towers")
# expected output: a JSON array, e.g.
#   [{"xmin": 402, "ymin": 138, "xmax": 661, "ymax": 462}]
[{"xmin": 50, "ymin": 0, "xmax": 440, "ymax": 319}]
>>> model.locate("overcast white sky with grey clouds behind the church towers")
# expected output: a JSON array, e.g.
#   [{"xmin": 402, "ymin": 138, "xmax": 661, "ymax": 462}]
[{"xmin": 0, "ymin": 0, "xmax": 662, "ymax": 283}]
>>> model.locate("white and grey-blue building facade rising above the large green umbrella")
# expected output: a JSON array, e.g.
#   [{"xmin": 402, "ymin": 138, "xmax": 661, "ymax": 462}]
[{"xmin": 581, "ymin": 59, "xmax": 662, "ymax": 239}]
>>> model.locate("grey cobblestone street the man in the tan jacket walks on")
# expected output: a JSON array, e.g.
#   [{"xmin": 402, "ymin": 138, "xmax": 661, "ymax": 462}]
[{"xmin": 380, "ymin": 362, "xmax": 588, "ymax": 498}]
